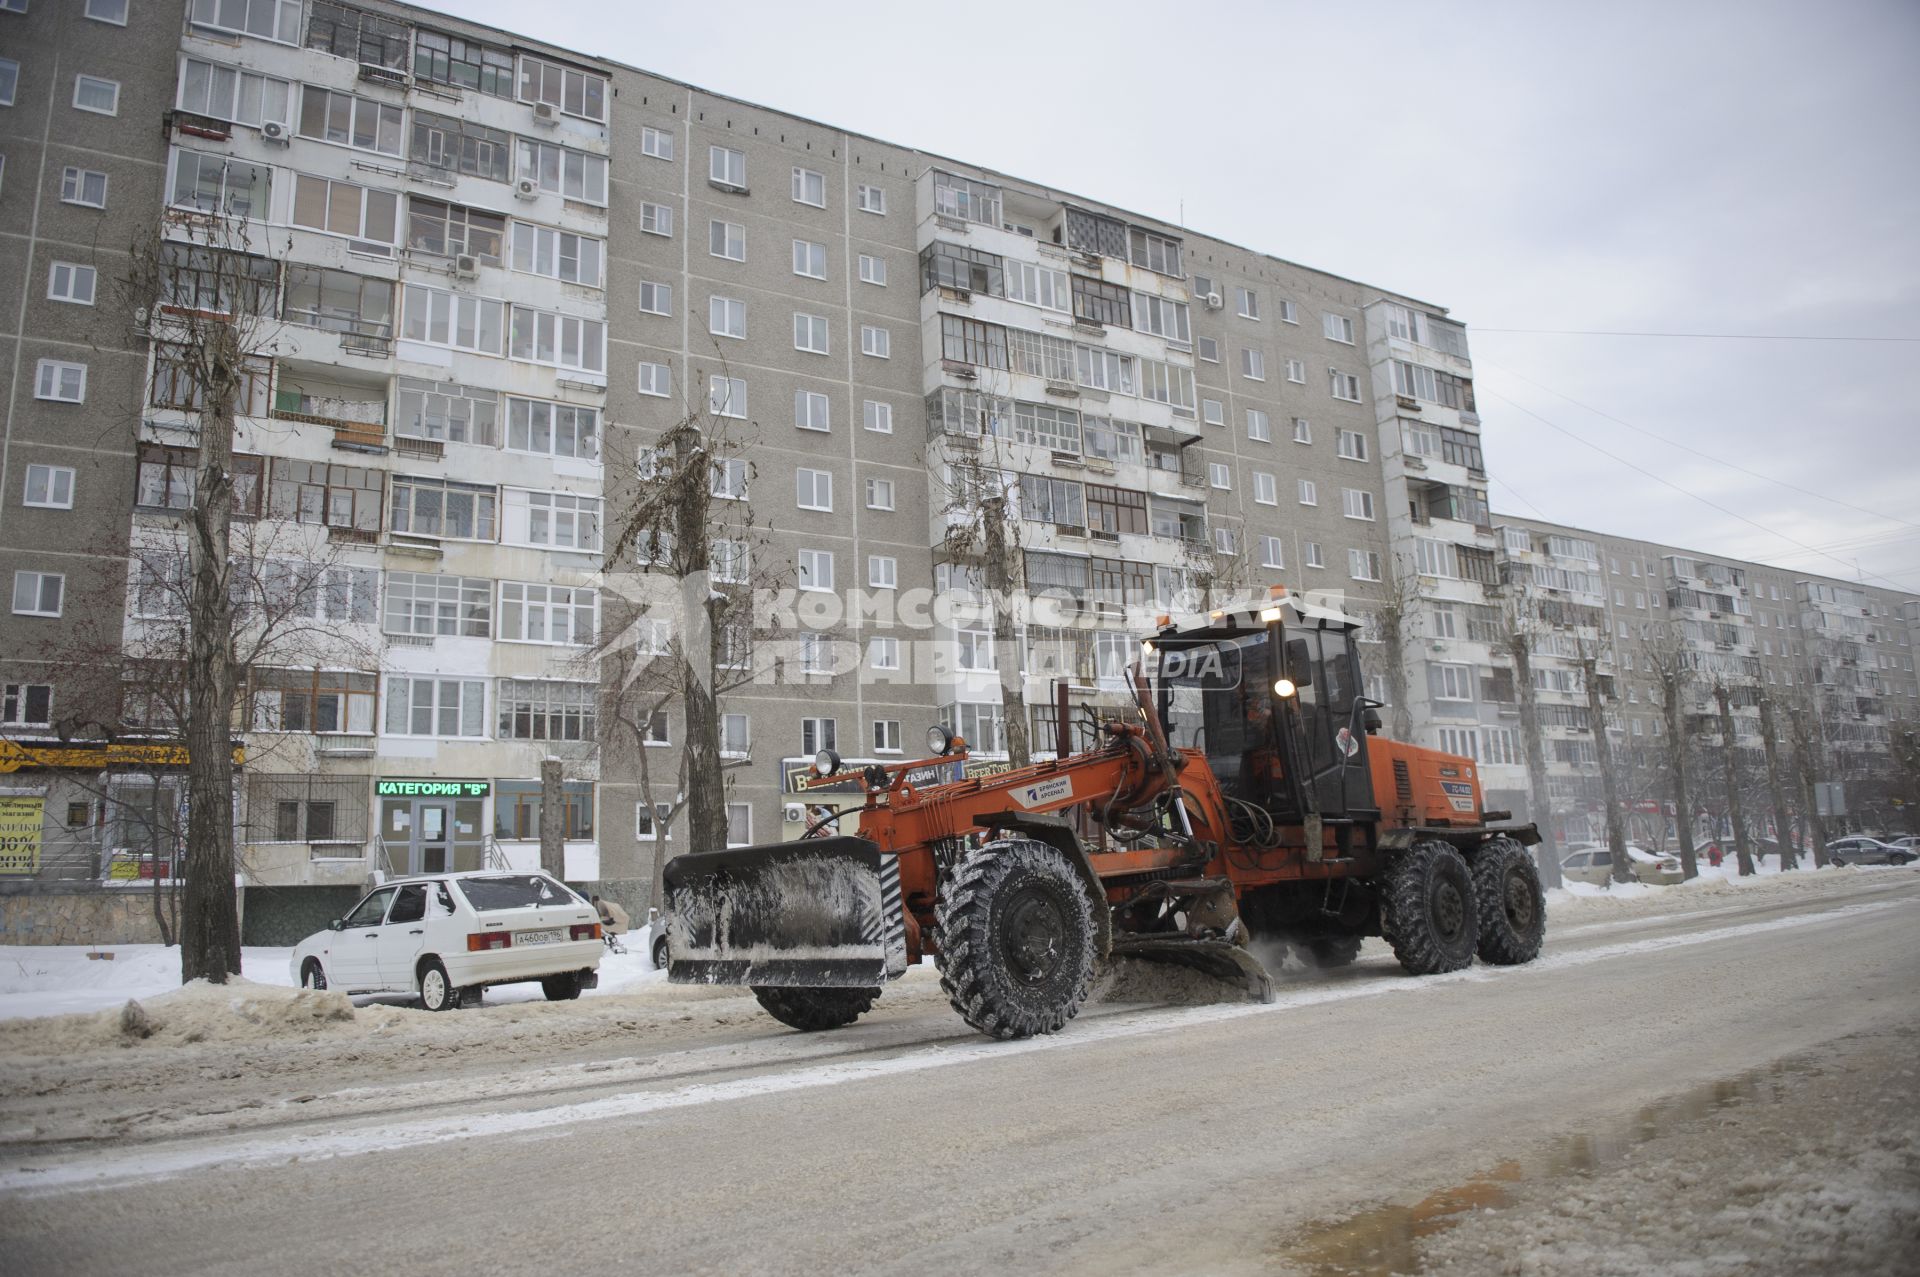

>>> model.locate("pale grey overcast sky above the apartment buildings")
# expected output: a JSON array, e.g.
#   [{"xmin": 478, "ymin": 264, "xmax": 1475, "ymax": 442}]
[{"xmin": 438, "ymin": 0, "xmax": 1920, "ymax": 593}]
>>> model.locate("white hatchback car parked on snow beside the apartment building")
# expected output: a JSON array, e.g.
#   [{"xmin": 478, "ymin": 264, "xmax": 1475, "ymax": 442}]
[{"xmin": 288, "ymin": 870, "xmax": 605, "ymax": 1010}]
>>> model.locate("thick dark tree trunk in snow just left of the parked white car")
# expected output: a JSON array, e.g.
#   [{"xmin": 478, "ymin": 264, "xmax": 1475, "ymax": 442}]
[{"xmin": 180, "ymin": 325, "xmax": 242, "ymax": 985}]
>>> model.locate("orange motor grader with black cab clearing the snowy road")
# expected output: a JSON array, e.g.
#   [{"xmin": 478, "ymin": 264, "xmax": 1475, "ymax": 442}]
[{"xmin": 666, "ymin": 590, "xmax": 1546, "ymax": 1039}]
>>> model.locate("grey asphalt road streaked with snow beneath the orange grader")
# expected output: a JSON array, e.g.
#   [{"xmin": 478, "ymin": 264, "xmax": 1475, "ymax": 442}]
[{"xmin": 0, "ymin": 872, "xmax": 1920, "ymax": 1275}]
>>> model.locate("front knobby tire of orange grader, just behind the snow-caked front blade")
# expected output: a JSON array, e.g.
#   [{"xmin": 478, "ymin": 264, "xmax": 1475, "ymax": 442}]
[{"xmin": 937, "ymin": 839, "xmax": 1094, "ymax": 1039}]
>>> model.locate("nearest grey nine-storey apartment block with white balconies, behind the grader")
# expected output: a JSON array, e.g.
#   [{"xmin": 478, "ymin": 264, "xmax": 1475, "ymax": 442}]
[{"xmin": 0, "ymin": 0, "xmax": 1904, "ymax": 910}]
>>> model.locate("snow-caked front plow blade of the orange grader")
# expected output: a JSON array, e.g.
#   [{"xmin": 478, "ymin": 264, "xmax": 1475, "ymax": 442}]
[{"xmin": 666, "ymin": 837, "xmax": 906, "ymax": 989}]
